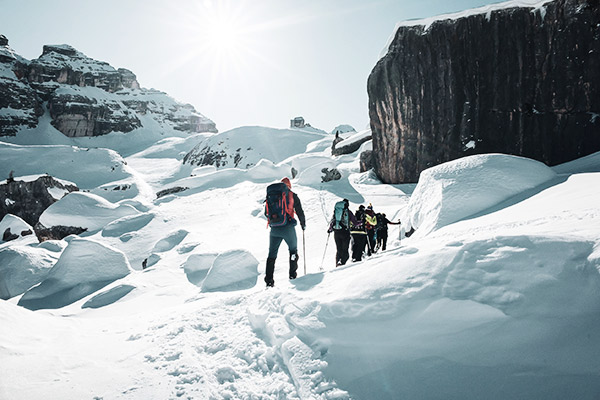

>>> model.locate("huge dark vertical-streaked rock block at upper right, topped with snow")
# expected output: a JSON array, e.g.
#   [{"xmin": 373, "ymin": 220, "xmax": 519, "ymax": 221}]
[{"xmin": 368, "ymin": 0, "xmax": 600, "ymax": 183}]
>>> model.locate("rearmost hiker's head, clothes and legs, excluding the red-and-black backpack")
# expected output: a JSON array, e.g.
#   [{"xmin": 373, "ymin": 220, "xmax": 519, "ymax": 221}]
[{"xmin": 265, "ymin": 178, "xmax": 306, "ymax": 286}]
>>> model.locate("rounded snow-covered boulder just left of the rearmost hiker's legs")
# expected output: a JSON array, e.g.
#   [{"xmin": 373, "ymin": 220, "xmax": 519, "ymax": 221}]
[{"xmin": 202, "ymin": 250, "xmax": 258, "ymax": 292}]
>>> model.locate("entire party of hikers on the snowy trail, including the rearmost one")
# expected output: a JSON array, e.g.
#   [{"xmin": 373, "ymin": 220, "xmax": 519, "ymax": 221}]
[{"xmin": 265, "ymin": 178, "xmax": 400, "ymax": 287}]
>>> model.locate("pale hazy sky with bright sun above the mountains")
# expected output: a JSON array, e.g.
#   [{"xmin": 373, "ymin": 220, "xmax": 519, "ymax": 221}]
[{"xmin": 0, "ymin": 0, "xmax": 504, "ymax": 131}]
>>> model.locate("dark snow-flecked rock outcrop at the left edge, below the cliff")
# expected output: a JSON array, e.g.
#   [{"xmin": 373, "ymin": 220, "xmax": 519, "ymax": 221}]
[{"xmin": 0, "ymin": 175, "xmax": 79, "ymax": 226}]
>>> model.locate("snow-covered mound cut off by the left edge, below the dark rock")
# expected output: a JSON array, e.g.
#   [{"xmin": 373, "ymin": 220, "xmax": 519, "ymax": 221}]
[{"xmin": 0, "ymin": 245, "xmax": 60, "ymax": 300}]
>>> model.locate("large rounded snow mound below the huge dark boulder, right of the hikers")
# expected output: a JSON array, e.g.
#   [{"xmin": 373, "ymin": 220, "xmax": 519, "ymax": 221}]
[{"xmin": 403, "ymin": 154, "xmax": 556, "ymax": 237}]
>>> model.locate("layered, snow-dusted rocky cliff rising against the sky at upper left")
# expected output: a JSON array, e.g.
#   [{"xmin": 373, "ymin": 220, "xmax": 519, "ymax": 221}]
[{"xmin": 0, "ymin": 35, "xmax": 217, "ymax": 137}]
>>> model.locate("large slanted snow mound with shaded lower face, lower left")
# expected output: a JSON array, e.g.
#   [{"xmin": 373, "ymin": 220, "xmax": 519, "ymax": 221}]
[{"xmin": 19, "ymin": 238, "xmax": 132, "ymax": 310}]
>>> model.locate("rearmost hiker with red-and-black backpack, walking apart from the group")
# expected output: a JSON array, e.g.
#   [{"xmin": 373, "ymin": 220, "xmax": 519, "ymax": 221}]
[{"xmin": 265, "ymin": 177, "xmax": 306, "ymax": 286}]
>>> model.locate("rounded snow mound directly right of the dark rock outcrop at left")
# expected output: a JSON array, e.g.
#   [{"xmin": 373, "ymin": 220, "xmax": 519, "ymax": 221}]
[{"xmin": 40, "ymin": 192, "xmax": 140, "ymax": 231}]
